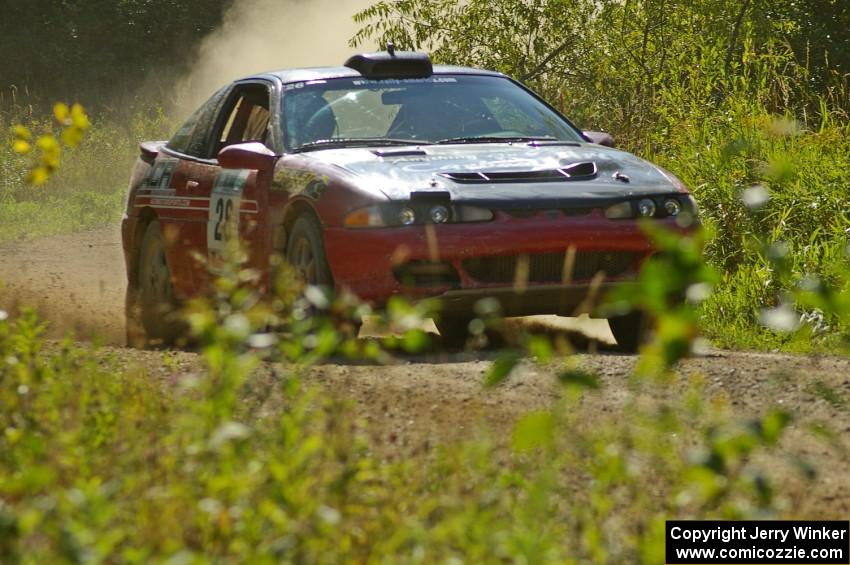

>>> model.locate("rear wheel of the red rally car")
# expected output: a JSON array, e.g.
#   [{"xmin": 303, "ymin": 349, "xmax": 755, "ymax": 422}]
[{"xmin": 131, "ymin": 220, "xmax": 186, "ymax": 347}]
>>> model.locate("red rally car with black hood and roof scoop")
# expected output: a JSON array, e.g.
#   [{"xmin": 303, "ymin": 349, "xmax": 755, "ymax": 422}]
[{"xmin": 122, "ymin": 50, "xmax": 696, "ymax": 349}]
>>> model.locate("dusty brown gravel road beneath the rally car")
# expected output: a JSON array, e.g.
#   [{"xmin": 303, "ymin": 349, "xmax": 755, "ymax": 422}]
[{"xmin": 0, "ymin": 228, "xmax": 850, "ymax": 519}]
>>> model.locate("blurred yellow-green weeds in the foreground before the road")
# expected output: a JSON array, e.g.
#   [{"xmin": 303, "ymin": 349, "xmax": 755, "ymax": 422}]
[{"xmin": 0, "ymin": 241, "xmax": 800, "ymax": 563}]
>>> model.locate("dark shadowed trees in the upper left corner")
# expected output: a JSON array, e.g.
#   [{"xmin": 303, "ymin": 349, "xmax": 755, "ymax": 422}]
[{"xmin": 0, "ymin": 0, "xmax": 230, "ymax": 107}]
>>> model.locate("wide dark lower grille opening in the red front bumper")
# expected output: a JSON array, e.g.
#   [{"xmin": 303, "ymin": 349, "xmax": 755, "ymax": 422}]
[{"xmin": 463, "ymin": 251, "xmax": 639, "ymax": 284}]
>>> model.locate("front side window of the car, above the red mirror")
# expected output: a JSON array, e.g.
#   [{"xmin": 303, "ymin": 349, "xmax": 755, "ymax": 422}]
[{"xmin": 213, "ymin": 84, "xmax": 270, "ymax": 153}]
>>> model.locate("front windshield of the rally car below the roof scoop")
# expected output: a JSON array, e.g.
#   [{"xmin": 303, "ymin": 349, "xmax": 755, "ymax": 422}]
[{"xmin": 282, "ymin": 75, "xmax": 583, "ymax": 151}]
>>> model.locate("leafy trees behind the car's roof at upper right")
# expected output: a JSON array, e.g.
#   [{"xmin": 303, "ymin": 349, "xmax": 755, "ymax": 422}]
[{"xmin": 351, "ymin": 0, "xmax": 840, "ymax": 148}]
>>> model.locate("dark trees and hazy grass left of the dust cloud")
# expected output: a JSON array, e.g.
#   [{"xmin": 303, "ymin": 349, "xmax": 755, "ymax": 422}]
[{"xmin": 0, "ymin": 0, "xmax": 230, "ymax": 243}]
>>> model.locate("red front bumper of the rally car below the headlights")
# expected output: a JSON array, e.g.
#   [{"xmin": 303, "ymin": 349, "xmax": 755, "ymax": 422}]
[{"xmin": 324, "ymin": 210, "xmax": 687, "ymax": 316}]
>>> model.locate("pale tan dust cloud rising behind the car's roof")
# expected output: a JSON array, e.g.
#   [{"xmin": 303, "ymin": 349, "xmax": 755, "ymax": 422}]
[{"xmin": 175, "ymin": 0, "xmax": 377, "ymax": 114}]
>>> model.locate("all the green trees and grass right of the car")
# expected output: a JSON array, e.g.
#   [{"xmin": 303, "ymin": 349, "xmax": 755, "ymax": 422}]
[{"xmin": 351, "ymin": 0, "xmax": 850, "ymax": 351}]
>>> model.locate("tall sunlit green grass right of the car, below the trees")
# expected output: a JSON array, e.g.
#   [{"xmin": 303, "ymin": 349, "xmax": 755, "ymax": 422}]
[{"xmin": 649, "ymin": 98, "xmax": 850, "ymax": 352}]
